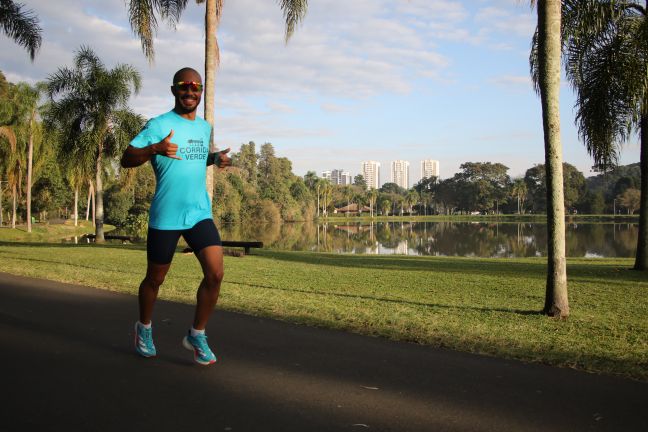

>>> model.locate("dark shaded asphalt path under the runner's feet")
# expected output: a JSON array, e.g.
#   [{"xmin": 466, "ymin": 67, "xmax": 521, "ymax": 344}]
[{"xmin": 0, "ymin": 273, "xmax": 648, "ymax": 432}]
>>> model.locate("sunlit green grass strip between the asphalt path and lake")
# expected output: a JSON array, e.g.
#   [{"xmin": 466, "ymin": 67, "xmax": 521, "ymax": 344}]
[{"xmin": 0, "ymin": 243, "xmax": 648, "ymax": 381}]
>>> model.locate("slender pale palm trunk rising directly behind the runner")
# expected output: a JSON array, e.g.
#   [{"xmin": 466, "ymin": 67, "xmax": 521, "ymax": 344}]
[{"xmin": 203, "ymin": 0, "xmax": 222, "ymax": 201}]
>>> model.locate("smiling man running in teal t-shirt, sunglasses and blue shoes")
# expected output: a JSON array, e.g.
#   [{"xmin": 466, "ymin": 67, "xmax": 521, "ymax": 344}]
[{"xmin": 121, "ymin": 68, "xmax": 231, "ymax": 365}]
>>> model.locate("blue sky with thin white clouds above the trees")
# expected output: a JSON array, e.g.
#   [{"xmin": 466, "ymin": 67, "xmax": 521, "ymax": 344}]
[{"xmin": 0, "ymin": 0, "xmax": 639, "ymax": 185}]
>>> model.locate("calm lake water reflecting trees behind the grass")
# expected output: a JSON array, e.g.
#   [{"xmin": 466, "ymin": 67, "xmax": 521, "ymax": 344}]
[{"xmin": 221, "ymin": 222, "xmax": 638, "ymax": 258}]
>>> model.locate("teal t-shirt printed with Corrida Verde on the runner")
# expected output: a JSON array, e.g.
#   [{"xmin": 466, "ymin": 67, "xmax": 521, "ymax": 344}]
[{"xmin": 130, "ymin": 111, "xmax": 212, "ymax": 230}]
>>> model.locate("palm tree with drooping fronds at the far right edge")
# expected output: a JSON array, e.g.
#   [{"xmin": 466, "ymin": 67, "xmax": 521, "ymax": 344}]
[{"xmin": 548, "ymin": 0, "xmax": 648, "ymax": 270}]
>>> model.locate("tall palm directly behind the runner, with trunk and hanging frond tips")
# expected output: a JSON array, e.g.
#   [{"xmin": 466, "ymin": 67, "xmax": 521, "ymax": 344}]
[{"xmin": 127, "ymin": 0, "xmax": 308, "ymax": 197}]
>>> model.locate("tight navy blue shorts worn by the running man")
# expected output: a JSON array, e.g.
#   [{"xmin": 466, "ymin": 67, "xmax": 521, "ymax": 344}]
[{"xmin": 146, "ymin": 219, "xmax": 222, "ymax": 264}]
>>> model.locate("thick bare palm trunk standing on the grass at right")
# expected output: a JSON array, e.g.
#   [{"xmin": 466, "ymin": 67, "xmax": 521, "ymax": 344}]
[{"xmin": 538, "ymin": 0, "xmax": 569, "ymax": 318}]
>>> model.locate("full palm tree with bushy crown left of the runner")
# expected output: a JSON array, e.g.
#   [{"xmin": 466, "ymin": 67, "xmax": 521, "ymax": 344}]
[{"xmin": 47, "ymin": 46, "xmax": 141, "ymax": 243}]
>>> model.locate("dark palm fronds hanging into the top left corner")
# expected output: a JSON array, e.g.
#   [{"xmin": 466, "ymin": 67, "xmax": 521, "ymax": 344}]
[{"xmin": 0, "ymin": 0, "xmax": 42, "ymax": 61}]
